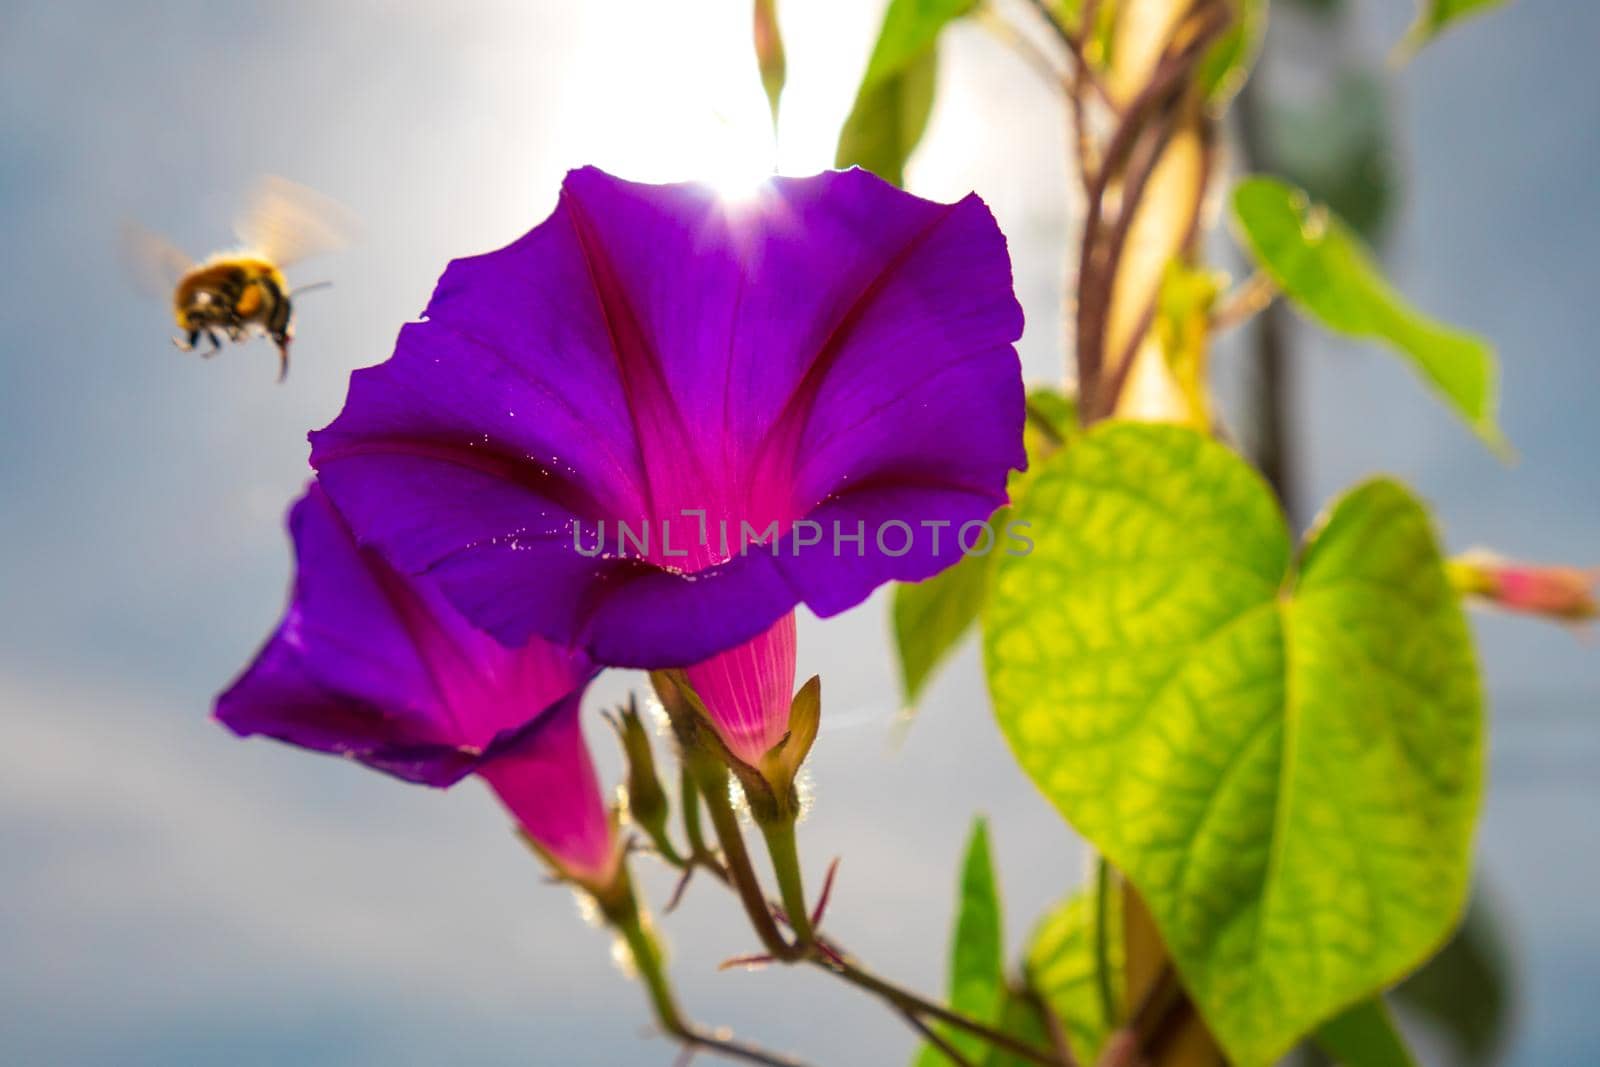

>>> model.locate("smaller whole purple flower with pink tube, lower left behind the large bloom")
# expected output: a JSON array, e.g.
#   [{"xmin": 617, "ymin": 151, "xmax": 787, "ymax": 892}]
[{"xmin": 216, "ymin": 485, "xmax": 618, "ymax": 881}]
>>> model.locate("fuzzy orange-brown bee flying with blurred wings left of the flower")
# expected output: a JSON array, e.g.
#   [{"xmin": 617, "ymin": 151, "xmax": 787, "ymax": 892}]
[{"xmin": 123, "ymin": 178, "xmax": 350, "ymax": 381}]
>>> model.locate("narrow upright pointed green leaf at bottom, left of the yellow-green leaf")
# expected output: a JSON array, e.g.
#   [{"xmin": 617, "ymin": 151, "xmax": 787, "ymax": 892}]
[{"xmin": 915, "ymin": 819, "xmax": 1005, "ymax": 1067}]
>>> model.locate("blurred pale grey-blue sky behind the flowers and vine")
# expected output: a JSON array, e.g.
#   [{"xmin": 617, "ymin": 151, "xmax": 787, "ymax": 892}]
[{"xmin": 0, "ymin": 0, "xmax": 1600, "ymax": 1067}]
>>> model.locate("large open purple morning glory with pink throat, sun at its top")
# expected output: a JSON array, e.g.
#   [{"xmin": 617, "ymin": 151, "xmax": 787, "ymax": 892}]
[{"xmin": 312, "ymin": 168, "xmax": 1026, "ymax": 767}]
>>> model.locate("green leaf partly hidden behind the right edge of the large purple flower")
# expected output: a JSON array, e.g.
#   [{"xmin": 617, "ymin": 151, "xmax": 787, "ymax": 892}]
[{"xmin": 893, "ymin": 387, "xmax": 1078, "ymax": 707}]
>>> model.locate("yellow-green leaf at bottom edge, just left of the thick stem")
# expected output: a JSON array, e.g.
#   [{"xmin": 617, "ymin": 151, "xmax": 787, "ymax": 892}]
[{"xmin": 1027, "ymin": 886, "xmax": 1123, "ymax": 1064}]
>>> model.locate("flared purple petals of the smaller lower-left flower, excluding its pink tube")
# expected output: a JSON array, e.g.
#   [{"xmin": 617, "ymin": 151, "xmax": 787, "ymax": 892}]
[{"xmin": 218, "ymin": 485, "xmax": 587, "ymax": 785}]
